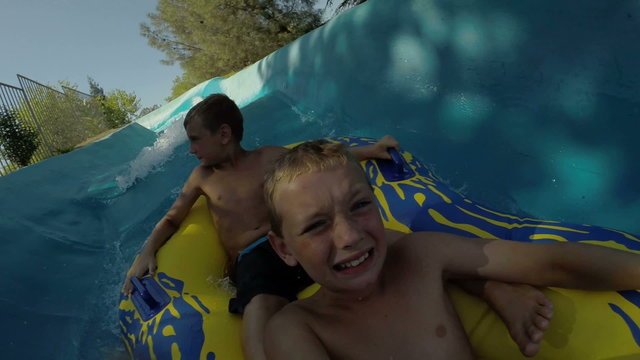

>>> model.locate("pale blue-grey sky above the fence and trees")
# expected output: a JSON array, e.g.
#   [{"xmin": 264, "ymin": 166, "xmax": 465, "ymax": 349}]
[{"xmin": 0, "ymin": 0, "xmax": 182, "ymax": 108}]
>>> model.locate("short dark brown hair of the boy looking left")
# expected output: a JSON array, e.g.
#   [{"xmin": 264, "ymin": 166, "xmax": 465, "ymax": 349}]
[{"xmin": 183, "ymin": 94, "xmax": 244, "ymax": 142}]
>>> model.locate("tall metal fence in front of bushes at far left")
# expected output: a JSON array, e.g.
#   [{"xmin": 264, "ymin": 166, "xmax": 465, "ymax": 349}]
[{"xmin": 0, "ymin": 75, "xmax": 110, "ymax": 176}]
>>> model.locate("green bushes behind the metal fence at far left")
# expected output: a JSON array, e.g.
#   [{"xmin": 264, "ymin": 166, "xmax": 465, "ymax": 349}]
[{"xmin": 0, "ymin": 78, "xmax": 140, "ymax": 170}]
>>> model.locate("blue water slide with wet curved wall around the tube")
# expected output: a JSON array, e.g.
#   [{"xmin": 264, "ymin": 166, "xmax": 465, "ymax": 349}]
[{"xmin": 0, "ymin": 0, "xmax": 640, "ymax": 359}]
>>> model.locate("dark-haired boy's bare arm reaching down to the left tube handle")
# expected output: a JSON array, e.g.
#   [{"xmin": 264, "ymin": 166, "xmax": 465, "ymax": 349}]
[{"xmin": 122, "ymin": 168, "xmax": 202, "ymax": 295}]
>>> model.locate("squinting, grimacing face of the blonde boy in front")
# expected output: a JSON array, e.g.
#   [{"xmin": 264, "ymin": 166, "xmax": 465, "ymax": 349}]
[{"xmin": 271, "ymin": 164, "xmax": 386, "ymax": 292}]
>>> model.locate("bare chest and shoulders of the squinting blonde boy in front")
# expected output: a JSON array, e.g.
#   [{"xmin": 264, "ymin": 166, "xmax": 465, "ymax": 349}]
[{"xmin": 272, "ymin": 235, "xmax": 473, "ymax": 359}]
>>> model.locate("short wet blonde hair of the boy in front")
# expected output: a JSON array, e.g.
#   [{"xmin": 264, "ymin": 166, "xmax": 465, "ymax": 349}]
[{"xmin": 264, "ymin": 140, "xmax": 364, "ymax": 237}]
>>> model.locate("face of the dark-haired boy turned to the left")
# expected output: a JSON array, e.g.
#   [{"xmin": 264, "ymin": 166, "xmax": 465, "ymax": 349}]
[{"xmin": 185, "ymin": 119, "xmax": 228, "ymax": 166}]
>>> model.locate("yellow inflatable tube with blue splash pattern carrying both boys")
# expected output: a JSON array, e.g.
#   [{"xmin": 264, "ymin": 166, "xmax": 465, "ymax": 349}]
[{"xmin": 119, "ymin": 137, "xmax": 640, "ymax": 360}]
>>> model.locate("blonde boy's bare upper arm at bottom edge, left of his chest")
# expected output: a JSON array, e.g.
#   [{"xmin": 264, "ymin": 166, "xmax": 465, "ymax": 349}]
[{"xmin": 264, "ymin": 309, "xmax": 329, "ymax": 360}]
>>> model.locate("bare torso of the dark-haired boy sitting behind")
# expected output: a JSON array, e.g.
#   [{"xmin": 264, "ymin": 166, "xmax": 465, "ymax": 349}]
[{"xmin": 196, "ymin": 146, "xmax": 285, "ymax": 261}]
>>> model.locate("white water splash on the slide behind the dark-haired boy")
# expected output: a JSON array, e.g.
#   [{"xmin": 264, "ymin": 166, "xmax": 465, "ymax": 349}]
[{"xmin": 116, "ymin": 112, "xmax": 187, "ymax": 191}]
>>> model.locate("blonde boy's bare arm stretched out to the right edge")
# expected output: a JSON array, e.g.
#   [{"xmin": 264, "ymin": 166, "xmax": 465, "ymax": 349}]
[{"xmin": 418, "ymin": 233, "xmax": 640, "ymax": 290}]
